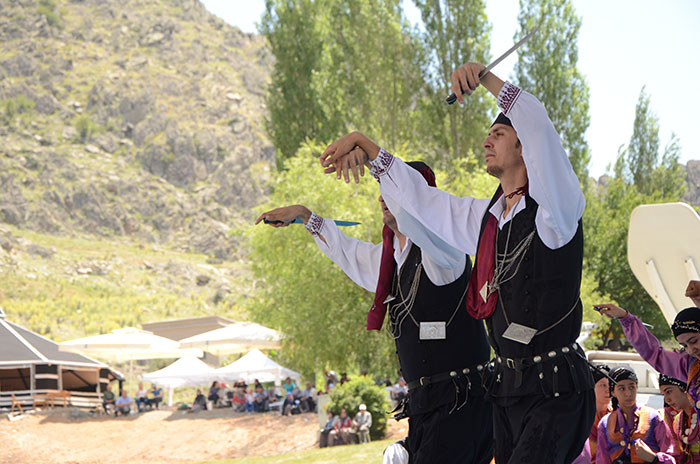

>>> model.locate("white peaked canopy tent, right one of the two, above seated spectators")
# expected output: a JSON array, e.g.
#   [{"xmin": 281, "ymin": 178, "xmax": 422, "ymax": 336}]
[{"xmin": 215, "ymin": 348, "xmax": 301, "ymax": 386}]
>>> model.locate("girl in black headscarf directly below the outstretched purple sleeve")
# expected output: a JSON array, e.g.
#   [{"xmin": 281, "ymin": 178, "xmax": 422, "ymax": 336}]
[{"xmin": 659, "ymin": 374, "xmax": 700, "ymax": 464}]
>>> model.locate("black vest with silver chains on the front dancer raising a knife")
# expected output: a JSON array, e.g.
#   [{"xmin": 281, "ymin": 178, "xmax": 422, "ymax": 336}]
[{"xmin": 477, "ymin": 187, "xmax": 593, "ymax": 397}]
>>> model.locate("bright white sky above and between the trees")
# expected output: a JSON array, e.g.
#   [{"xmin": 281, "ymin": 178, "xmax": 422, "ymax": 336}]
[{"xmin": 208, "ymin": 0, "xmax": 700, "ymax": 177}]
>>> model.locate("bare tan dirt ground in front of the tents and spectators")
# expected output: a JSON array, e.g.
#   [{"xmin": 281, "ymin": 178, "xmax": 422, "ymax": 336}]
[{"xmin": 0, "ymin": 408, "xmax": 408, "ymax": 464}]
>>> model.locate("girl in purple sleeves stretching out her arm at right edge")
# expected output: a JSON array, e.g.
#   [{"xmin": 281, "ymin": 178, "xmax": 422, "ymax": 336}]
[{"xmin": 597, "ymin": 298, "xmax": 700, "ymax": 454}]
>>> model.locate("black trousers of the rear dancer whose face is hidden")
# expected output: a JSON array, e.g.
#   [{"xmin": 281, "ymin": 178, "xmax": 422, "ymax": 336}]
[{"xmin": 406, "ymin": 397, "xmax": 492, "ymax": 464}]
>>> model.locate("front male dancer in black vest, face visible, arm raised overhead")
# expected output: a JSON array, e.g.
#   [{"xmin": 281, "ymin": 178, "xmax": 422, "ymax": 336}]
[{"xmin": 321, "ymin": 63, "xmax": 595, "ymax": 464}]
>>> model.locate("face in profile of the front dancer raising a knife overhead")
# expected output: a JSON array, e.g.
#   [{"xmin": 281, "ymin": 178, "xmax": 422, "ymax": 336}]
[{"xmin": 482, "ymin": 124, "xmax": 524, "ymax": 178}]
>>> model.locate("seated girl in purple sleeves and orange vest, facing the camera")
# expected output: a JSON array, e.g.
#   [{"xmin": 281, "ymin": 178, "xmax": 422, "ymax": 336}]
[{"xmin": 596, "ymin": 367, "xmax": 676, "ymax": 464}]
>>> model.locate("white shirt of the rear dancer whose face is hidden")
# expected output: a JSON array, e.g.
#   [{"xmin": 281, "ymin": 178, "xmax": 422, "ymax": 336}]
[{"xmin": 306, "ymin": 208, "xmax": 467, "ymax": 292}]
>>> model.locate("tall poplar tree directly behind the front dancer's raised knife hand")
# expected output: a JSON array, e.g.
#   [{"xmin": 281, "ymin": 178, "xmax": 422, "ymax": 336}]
[{"xmin": 415, "ymin": 0, "xmax": 495, "ymax": 167}]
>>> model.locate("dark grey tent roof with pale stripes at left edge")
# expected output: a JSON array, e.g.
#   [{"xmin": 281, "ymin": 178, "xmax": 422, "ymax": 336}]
[{"xmin": 0, "ymin": 315, "xmax": 121, "ymax": 377}]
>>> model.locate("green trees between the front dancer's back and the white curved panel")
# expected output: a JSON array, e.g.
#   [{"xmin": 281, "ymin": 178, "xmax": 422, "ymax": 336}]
[{"xmin": 584, "ymin": 89, "xmax": 685, "ymax": 342}]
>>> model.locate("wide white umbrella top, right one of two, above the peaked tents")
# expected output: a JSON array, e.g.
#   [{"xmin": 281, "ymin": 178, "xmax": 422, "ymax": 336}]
[{"xmin": 180, "ymin": 322, "xmax": 281, "ymax": 355}]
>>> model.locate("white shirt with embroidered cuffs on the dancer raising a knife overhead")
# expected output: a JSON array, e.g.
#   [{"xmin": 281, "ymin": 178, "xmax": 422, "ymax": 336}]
[{"xmin": 371, "ymin": 82, "xmax": 585, "ymax": 252}]
